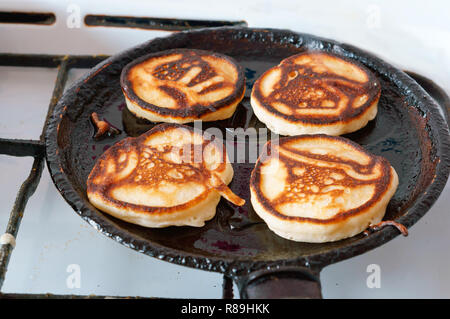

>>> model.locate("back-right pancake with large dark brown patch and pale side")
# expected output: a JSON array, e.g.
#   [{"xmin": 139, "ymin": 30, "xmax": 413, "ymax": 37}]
[{"xmin": 251, "ymin": 52, "xmax": 381, "ymax": 136}]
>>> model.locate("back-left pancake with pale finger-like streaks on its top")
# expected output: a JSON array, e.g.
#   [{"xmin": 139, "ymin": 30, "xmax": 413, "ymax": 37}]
[{"xmin": 121, "ymin": 49, "xmax": 245, "ymax": 123}]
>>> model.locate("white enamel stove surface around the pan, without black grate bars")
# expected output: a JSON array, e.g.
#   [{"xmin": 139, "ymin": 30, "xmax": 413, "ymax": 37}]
[{"xmin": 0, "ymin": 0, "xmax": 450, "ymax": 298}]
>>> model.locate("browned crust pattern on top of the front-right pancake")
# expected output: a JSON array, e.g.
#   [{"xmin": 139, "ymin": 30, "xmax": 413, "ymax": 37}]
[{"xmin": 250, "ymin": 134, "xmax": 393, "ymax": 224}]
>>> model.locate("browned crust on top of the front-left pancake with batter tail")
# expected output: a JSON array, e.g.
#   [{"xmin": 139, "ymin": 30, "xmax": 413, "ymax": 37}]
[{"xmin": 87, "ymin": 123, "xmax": 227, "ymax": 215}]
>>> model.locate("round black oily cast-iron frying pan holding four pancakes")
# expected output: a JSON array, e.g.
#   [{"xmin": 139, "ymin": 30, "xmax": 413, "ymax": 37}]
[{"xmin": 46, "ymin": 27, "xmax": 450, "ymax": 298}]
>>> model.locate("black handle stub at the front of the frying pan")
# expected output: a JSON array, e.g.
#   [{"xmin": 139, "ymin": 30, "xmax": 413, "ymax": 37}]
[{"xmin": 236, "ymin": 267, "xmax": 322, "ymax": 299}]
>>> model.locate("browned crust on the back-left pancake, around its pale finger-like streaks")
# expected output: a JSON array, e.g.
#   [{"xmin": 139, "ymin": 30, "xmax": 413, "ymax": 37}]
[{"xmin": 120, "ymin": 49, "xmax": 245, "ymax": 119}]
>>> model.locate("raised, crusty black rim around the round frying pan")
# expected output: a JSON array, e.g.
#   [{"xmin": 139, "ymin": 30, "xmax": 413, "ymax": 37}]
[{"xmin": 45, "ymin": 27, "xmax": 450, "ymax": 277}]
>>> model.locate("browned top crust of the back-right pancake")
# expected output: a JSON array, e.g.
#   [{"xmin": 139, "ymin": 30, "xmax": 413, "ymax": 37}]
[{"xmin": 252, "ymin": 51, "xmax": 381, "ymax": 125}]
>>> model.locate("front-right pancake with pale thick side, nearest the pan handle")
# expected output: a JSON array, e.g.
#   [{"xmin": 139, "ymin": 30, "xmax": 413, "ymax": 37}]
[{"xmin": 250, "ymin": 134, "xmax": 398, "ymax": 243}]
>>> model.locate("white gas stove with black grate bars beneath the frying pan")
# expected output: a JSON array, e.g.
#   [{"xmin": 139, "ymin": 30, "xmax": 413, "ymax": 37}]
[{"xmin": 0, "ymin": 1, "xmax": 450, "ymax": 298}]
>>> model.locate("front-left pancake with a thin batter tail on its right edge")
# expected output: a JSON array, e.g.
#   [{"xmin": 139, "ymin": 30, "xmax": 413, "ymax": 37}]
[{"xmin": 87, "ymin": 124, "xmax": 244, "ymax": 227}]
